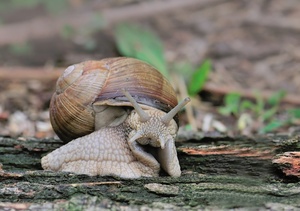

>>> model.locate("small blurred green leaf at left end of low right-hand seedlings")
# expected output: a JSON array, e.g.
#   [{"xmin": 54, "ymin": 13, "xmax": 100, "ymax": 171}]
[{"xmin": 218, "ymin": 93, "xmax": 241, "ymax": 115}]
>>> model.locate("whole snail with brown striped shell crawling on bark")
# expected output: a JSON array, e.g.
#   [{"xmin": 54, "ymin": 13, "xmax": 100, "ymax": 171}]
[{"xmin": 41, "ymin": 57, "xmax": 189, "ymax": 178}]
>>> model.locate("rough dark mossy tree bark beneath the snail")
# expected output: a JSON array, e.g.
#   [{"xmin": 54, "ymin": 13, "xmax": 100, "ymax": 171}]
[{"xmin": 0, "ymin": 134, "xmax": 300, "ymax": 210}]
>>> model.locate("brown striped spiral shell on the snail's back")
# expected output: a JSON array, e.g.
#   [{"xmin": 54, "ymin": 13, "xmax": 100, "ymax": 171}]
[{"xmin": 50, "ymin": 57, "xmax": 177, "ymax": 142}]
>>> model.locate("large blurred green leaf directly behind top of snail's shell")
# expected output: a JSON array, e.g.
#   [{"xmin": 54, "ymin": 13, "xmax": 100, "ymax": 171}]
[{"xmin": 115, "ymin": 24, "xmax": 169, "ymax": 77}]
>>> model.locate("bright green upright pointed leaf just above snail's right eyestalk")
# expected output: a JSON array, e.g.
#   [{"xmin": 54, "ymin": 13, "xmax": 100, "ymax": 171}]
[{"xmin": 188, "ymin": 59, "xmax": 211, "ymax": 96}]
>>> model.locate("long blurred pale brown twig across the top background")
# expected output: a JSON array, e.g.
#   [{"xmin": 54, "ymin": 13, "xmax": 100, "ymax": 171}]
[{"xmin": 0, "ymin": 0, "xmax": 225, "ymax": 46}]
